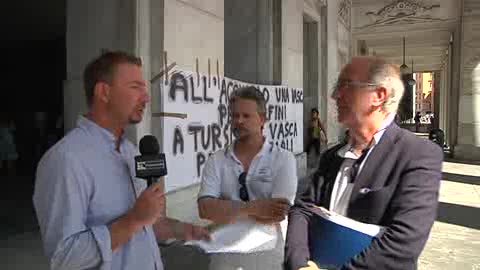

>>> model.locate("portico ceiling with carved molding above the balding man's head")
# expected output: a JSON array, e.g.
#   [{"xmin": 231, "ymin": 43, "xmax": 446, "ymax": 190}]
[{"xmin": 352, "ymin": 0, "xmax": 460, "ymax": 71}]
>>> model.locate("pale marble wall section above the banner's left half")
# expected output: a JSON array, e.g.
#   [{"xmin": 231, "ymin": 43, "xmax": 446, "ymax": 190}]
[{"xmin": 163, "ymin": 0, "xmax": 224, "ymax": 75}]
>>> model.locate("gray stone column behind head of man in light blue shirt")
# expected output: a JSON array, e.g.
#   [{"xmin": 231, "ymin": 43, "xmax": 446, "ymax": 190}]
[{"xmin": 64, "ymin": 0, "xmax": 136, "ymax": 134}]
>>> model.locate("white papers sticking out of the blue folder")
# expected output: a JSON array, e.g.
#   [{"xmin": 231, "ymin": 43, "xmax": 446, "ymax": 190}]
[{"xmin": 317, "ymin": 207, "xmax": 384, "ymax": 237}]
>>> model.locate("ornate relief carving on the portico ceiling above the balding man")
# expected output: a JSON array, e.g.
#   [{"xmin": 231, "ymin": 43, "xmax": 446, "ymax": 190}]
[{"xmin": 363, "ymin": 0, "xmax": 442, "ymax": 27}]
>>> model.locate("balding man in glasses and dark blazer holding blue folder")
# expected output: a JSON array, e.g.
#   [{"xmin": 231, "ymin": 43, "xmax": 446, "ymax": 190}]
[{"xmin": 285, "ymin": 57, "xmax": 443, "ymax": 270}]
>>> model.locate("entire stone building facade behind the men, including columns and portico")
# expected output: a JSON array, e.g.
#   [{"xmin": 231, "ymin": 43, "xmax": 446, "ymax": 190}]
[{"xmin": 64, "ymin": 0, "xmax": 480, "ymax": 224}]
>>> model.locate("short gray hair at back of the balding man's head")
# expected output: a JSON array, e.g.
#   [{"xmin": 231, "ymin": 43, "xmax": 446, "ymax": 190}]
[{"xmin": 368, "ymin": 58, "xmax": 405, "ymax": 113}]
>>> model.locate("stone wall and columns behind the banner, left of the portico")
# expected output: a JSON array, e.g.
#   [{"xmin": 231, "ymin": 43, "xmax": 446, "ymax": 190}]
[{"xmin": 64, "ymin": 0, "xmax": 352, "ymax": 221}]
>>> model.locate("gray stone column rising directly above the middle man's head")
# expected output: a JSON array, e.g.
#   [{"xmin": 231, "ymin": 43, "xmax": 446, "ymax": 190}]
[{"xmin": 224, "ymin": 0, "xmax": 281, "ymax": 84}]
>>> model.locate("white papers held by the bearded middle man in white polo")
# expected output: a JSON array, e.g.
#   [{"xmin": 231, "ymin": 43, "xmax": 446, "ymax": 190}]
[{"xmin": 185, "ymin": 221, "xmax": 277, "ymax": 253}]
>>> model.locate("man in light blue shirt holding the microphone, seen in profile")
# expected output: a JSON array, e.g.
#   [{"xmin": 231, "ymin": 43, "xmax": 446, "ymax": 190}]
[{"xmin": 33, "ymin": 52, "xmax": 208, "ymax": 270}]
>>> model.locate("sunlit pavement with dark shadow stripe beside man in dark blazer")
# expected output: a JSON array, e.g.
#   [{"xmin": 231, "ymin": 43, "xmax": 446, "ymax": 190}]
[{"xmin": 419, "ymin": 158, "xmax": 480, "ymax": 270}]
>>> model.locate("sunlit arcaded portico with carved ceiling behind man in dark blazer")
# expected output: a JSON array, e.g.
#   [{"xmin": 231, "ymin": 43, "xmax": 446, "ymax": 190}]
[{"xmin": 352, "ymin": 0, "xmax": 480, "ymax": 161}]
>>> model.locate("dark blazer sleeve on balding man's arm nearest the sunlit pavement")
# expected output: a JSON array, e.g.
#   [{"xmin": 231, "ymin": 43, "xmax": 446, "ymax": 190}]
[{"xmin": 341, "ymin": 140, "xmax": 443, "ymax": 270}]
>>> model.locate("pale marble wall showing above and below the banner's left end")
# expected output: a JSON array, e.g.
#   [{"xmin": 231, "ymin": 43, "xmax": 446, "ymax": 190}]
[{"xmin": 156, "ymin": 0, "xmax": 224, "ymax": 224}]
